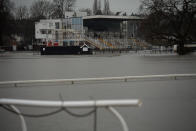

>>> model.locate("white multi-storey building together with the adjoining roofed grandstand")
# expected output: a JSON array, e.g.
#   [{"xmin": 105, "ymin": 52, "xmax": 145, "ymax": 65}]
[{"xmin": 35, "ymin": 12, "xmax": 149, "ymax": 50}]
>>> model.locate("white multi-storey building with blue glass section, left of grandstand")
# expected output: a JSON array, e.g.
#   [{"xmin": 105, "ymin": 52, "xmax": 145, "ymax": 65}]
[{"xmin": 35, "ymin": 17, "xmax": 83, "ymax": 46}]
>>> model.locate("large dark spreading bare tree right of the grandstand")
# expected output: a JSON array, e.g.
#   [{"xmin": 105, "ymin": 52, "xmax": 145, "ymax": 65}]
[{"xmin": 140, "ymin": 0, "xmax": 196, "ymax": 54}]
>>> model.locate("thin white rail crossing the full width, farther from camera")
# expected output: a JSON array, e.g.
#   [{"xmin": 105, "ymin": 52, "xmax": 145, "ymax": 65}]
[{"xmin": 0, "ymin": 74, "xmax": 196, "ymax": 87}]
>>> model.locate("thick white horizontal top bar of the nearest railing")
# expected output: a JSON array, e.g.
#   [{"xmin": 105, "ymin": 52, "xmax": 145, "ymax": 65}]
[{"xmin": 0, "ymin": 98, "xmax": 141, "ymax": 108}]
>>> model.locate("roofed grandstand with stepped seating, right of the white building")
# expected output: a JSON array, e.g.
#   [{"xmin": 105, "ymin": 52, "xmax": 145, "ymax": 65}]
[{"xmin": 83, "ymin": 15, "xmax": 148, "ymax": 50}]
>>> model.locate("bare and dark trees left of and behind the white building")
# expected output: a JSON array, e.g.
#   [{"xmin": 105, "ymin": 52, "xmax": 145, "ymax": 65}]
[{"xmin": 0, "ymin": 0, "xmax": 78, "ymax": 46}]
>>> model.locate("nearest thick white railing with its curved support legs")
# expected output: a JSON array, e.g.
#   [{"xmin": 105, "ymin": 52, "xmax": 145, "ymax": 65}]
[{"xmin": 0, "ymin": 98, "xmax": 142, "ymax": 131}]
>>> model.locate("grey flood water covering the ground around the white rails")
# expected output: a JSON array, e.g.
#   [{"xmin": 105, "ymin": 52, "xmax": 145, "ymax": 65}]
[{"xmin": 0, "ymin": 53, "xmax": 196, "ymax": 131}]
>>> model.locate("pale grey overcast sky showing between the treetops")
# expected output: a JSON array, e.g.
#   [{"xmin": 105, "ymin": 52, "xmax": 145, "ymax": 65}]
[{"xmin": 12, "ymin": 0, "xmax": 140, "ymax": 14}]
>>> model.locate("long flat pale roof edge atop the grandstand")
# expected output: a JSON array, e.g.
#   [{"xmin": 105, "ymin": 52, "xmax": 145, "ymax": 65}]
[{"xmin": 83, "ymin": 15, "xmax": 143, "ymax": 20}]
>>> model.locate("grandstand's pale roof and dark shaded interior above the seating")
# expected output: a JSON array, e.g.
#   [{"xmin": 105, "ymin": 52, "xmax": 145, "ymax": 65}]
[{"xmin": 83, "ymin": 15, "xmax": 142, "ymax": 37}]
